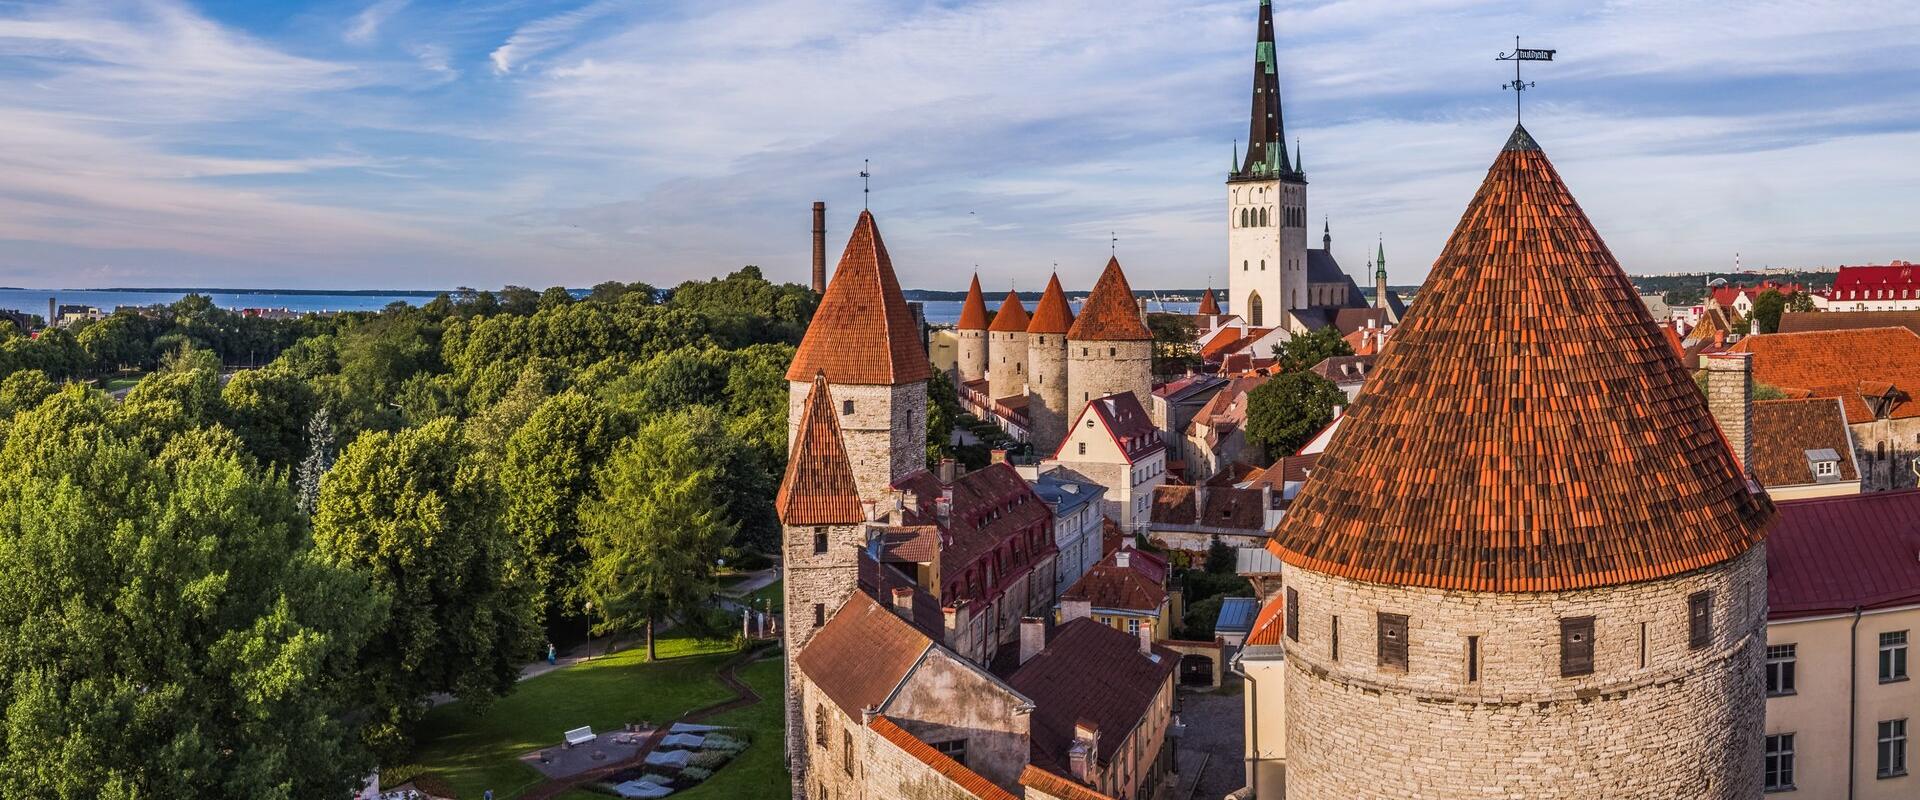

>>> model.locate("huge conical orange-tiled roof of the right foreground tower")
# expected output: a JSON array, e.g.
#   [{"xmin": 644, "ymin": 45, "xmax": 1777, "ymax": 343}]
[{"xmin": 1267, "ymin": 130, "xmax": 1772, "ymax": 591}]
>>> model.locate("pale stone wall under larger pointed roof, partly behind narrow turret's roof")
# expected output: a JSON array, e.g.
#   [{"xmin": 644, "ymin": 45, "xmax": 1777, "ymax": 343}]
[{"xmin": 787, "ymin": 382, "xmax": 927, "ymax": 501}]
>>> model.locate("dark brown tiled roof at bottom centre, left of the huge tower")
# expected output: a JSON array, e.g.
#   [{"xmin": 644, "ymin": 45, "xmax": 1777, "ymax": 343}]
[{"xmin": 1006, "ymin": 618, "xmax": 1181, "ymax": 773}]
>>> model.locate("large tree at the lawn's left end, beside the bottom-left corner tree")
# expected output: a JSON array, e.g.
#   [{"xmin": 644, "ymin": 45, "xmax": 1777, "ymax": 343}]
[{"xmin": 313, "ymin": 420, "xmax": 538, "ymax": 756}]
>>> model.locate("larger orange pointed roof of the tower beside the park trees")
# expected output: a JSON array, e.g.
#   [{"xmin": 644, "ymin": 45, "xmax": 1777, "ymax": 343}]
[{"xmin": 787, "ymin": 211, "xmax": 933, "ymax": 386}]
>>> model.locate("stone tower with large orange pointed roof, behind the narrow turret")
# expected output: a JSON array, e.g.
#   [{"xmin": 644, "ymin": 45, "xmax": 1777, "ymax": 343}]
[{"xmin": 787, "ymin": 211, "xmax": 933, "ymax": 499}]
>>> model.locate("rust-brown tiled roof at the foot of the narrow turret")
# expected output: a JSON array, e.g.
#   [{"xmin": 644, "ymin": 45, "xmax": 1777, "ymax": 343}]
[{"xmin": 799, "ymin": 591, "xmax": 933, "ymax": 719}]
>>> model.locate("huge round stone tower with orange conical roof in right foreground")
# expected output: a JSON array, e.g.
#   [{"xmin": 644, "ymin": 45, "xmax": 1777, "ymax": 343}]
[{"xmin": 1269, "ymin": 129, "xmax": 1772, "ymax": 800}]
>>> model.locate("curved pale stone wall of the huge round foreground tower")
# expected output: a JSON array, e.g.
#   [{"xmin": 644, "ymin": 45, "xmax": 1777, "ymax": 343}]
[{"xmin": 1284, "ymin": 545, "xmax": 1766, "ymax": 800}]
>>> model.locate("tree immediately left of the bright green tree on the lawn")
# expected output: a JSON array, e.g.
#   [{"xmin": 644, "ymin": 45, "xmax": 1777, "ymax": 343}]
[{"xmin": 499, "ymin": 391, "xmax": 624, "ymax": 629}]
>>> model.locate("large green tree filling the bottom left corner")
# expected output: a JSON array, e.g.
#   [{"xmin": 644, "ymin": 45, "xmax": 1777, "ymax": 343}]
[{"xmin": 0, "ymin": 397, "xmax": 378, "ymax": 800}]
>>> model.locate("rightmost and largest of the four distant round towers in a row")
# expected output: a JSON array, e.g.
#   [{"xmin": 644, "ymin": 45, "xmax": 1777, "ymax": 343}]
[{"xmin": 1066, "ymin": 259, "xmax": 1154, "ymax": 410}]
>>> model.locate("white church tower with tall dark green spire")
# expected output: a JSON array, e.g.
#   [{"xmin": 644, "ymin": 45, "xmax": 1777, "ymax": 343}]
[{"xmin": 1227, "ymin": 0, "xmax": 1309, "ymax": 328}]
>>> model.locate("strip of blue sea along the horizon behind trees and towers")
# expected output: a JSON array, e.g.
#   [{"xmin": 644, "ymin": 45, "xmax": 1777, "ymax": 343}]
[{"xmin": 0, "ymin": 288, "xmax": 1200, "ymax": 324}]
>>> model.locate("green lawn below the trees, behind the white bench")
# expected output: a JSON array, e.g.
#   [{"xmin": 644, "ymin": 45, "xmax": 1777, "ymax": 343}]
[{"xmin": 382, "ymin": 637, "xmax": 741, "ymax": 800}]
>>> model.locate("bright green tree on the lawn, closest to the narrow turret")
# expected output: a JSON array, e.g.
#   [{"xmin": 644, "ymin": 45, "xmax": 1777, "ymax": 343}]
[{"xmin": 580, "ymin": 411, "xmax": 733, "ymax": 658}]
